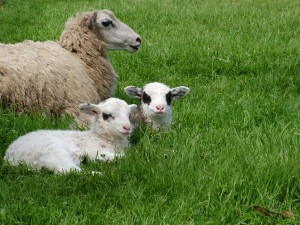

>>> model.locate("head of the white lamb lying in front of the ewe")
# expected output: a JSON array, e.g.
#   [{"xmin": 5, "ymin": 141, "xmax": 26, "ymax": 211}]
[{"xmin": 79, "ymin": 98, "xmax": 136, "ymax": 139}]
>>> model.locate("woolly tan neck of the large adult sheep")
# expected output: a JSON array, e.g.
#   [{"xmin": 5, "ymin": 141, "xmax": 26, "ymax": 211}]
[{"xmin": 60, "ymin": 13, "xmax": 118, "ymax": 100}]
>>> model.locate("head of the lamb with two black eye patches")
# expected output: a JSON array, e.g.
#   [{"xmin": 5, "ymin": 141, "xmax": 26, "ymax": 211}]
[{"xmin": 124, "ymin": 82, "xmax": 190, "ymax": 125}]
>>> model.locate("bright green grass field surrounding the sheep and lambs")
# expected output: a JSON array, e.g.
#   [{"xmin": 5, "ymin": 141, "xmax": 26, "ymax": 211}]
[{"xmin": 0, "ymin": 0, "xmax": 300, "ymax": 225}]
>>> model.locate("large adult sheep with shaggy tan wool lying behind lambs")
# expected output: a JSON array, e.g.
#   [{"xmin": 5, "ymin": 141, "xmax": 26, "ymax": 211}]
[{"xmin": 0, "ymin": 10, "xmax": 141, "ymax": 121}]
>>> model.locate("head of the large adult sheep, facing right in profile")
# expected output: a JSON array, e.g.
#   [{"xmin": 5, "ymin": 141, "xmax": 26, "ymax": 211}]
[{"xmin": 89, "ymin": 10, "xmax": 142, "ymax": 52}]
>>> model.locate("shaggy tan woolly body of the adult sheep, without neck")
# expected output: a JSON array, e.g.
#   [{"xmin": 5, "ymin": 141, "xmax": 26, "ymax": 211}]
[{"xmin": 0, "ymin": 41, "xmax": 99, "ymax": 115}]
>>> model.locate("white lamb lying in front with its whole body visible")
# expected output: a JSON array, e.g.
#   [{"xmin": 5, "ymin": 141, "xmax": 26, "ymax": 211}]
[{"xmin": 4, "ymin": 98, "xmax": 137, "ymax": 173}]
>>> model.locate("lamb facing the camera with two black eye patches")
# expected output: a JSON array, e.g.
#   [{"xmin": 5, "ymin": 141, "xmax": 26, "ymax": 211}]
[{"xmin": 124, "ymin": 82, "xmax": 190, "ymax": 129}]
